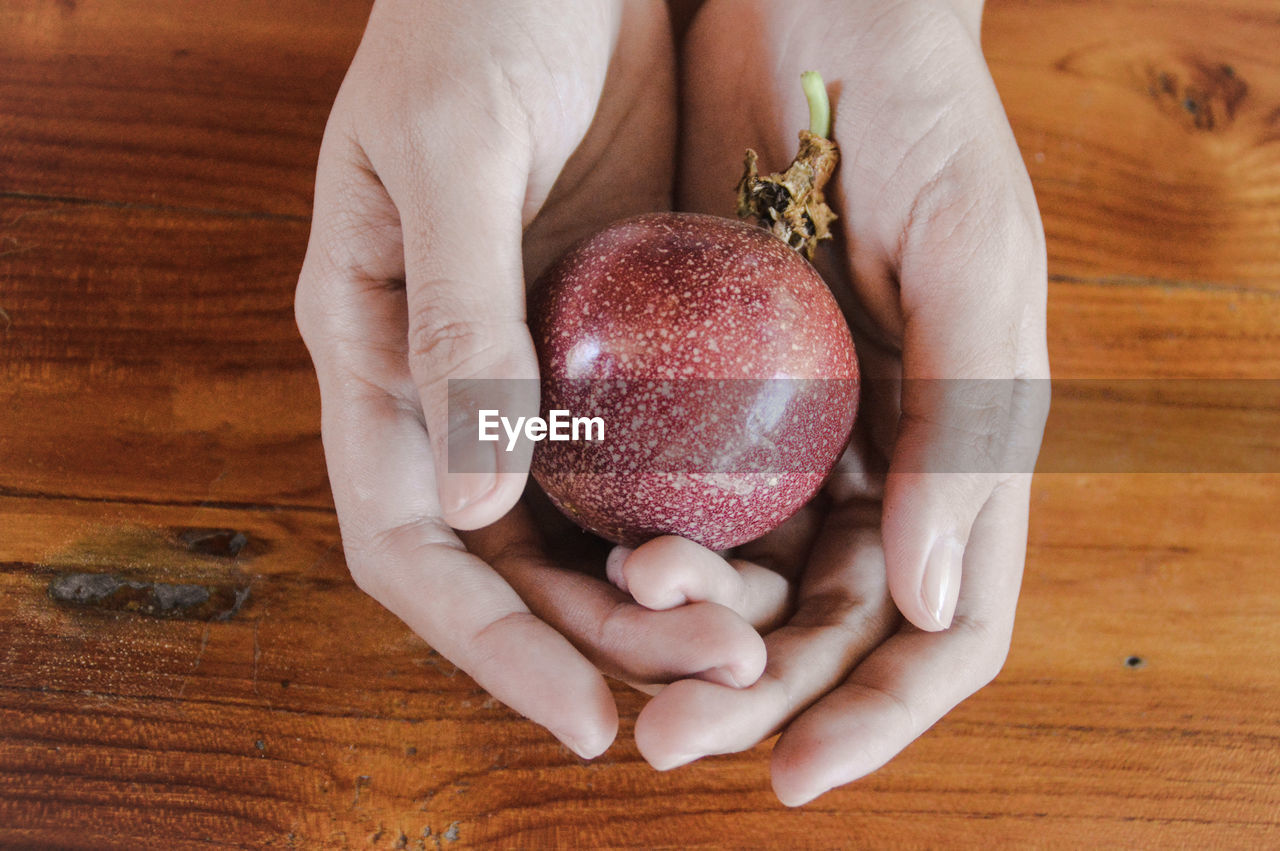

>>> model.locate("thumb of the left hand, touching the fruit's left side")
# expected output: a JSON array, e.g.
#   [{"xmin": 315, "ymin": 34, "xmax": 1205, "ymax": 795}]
[{"xmin": 387, "ymin": 130, "xmax": 538, "ymax": 530}]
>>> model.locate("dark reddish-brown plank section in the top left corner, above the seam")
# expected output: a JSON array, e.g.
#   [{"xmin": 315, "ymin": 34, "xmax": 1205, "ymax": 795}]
[{"xmin": 0, "ymin": 0, "xmax": 370, "ymax": 218}]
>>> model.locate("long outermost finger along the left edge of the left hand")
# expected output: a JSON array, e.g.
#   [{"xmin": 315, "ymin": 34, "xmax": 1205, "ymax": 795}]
[{"xmin": 297, "ymin": 127, "xmax": 617, "ymax": 756}]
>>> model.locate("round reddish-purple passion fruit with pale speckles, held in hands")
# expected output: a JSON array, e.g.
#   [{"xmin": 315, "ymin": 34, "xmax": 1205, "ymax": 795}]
[{"xmin": 529, "ymin": 212, "xmax": 858, "ymax": 550}]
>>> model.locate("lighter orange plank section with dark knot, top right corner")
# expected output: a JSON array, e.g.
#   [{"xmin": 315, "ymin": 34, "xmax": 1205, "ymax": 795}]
[{"xmin": 983, "ymin": 0, "xmax": 1280, "ymax": 292}]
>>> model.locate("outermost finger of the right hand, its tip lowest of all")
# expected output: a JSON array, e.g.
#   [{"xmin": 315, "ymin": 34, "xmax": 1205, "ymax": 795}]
[{"xmin": 773, "ymin": 476, "xmax": 1030, "ymax": 806}]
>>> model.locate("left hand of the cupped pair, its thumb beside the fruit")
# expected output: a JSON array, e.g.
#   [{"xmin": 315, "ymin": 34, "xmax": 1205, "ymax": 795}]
[{"xmin": 296, "ymin": 0, "xmax": 764, "ymax": 756}]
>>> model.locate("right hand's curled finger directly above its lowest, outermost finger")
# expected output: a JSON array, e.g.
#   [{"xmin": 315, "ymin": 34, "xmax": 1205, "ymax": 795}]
[{"xmin": 635, "ymin": 507, "xmax": 897, "ymax": 770}]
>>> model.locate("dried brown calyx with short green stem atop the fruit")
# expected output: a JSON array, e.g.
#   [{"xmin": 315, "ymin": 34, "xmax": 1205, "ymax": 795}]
[{"xmin": 737, "ymin": 72, "xmax": 840, "ymax": 260}]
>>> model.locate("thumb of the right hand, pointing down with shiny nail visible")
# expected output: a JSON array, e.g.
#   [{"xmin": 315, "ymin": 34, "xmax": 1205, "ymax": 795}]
[{"xmin": 882, "ymin": 156, "xmax": 1048, "ymax": 631}]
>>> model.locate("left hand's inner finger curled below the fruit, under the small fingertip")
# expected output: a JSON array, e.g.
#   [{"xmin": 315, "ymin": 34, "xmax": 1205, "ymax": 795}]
[{"xmin": 465, "ymin": 514, "xmax": 765, "ymax": 688}]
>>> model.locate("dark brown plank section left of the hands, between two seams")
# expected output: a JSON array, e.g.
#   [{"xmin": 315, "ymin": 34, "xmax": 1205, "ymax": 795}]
[{"xmin": 0, "ymin": 198, "xmax": 332, "ymax": 507}]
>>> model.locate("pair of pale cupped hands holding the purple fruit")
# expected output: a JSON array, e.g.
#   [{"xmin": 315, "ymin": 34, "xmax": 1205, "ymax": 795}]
[{"xmin": 297, "ymin": 0, "xmax": 1048, "ymax": 805}]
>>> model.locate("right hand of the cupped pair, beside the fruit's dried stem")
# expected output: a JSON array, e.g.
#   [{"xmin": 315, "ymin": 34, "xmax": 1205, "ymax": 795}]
[{"xmin": 612, "ymin": 0, "xmax": 1048, "ymax": 805}]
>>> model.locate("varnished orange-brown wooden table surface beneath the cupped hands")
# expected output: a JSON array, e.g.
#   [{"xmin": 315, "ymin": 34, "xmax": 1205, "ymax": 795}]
[{"xmin": 0, "ymin": 0, "xmax": 1280, "ymax": 848}]
